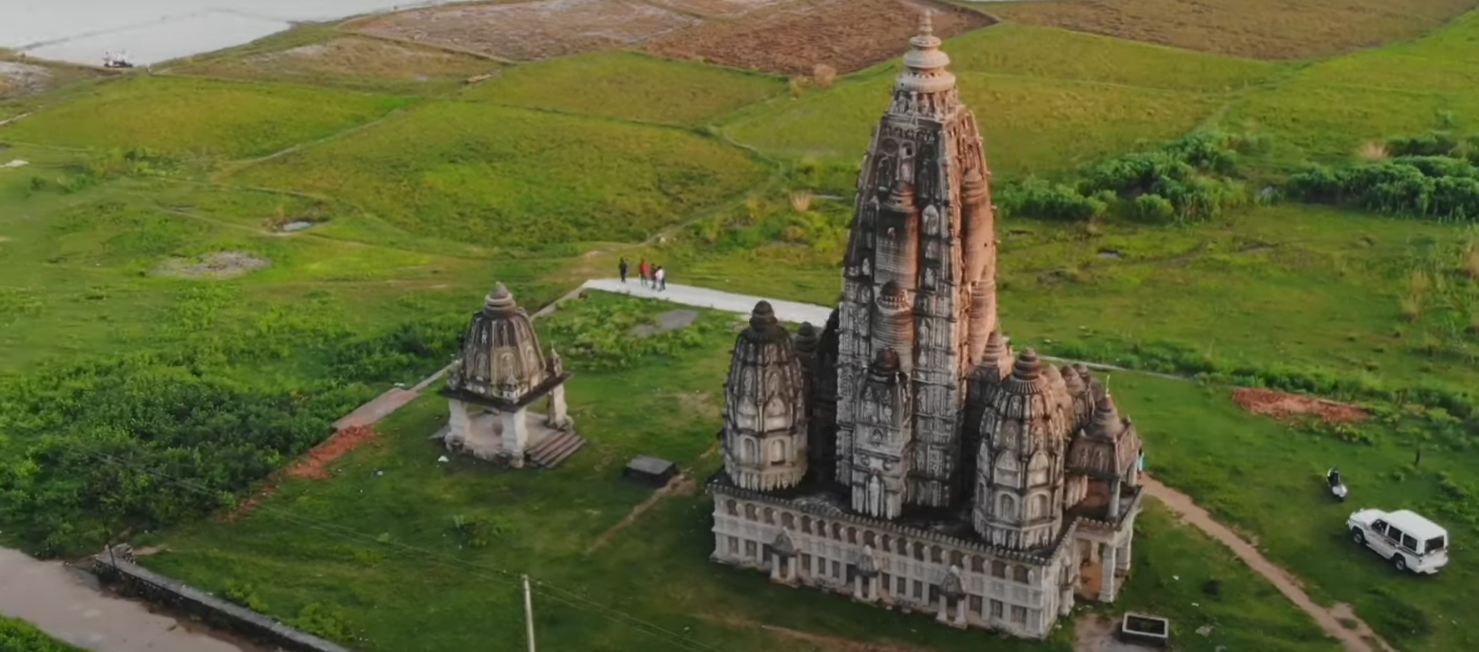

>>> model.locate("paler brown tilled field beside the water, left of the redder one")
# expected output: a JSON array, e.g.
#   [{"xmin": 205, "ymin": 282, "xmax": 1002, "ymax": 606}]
[{"xmin": 352, "ymin": 0, "xmax": 704, "ymax": 61}]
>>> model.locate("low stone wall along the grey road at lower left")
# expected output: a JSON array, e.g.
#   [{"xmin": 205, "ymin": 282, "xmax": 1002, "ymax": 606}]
[{"xmin": 93, "ymin": 546, "xmax": 351, "ymax": 652}]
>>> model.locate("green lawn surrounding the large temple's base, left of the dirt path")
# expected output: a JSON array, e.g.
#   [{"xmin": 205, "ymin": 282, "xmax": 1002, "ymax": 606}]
[{"xmin": 130, "ymin": 293, "xmax": 1338, "ymax": 651}]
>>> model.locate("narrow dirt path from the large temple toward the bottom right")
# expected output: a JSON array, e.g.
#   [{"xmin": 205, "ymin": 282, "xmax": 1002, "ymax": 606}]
[{"xmin": 1140, "ymin": 476, "xmax": 1396, "ymax": 652}]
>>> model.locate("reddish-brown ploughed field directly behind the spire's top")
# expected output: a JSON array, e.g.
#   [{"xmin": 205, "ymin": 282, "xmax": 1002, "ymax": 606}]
[{"xmin": 648, "ymin": 0, "xmax": 994, "ymax": 75}]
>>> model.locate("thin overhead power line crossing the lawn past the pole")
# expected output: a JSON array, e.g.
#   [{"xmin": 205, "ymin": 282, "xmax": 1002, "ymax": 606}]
[{"xmin": 78, "ymin": 451, "xmax": 726, "ymax": 652}]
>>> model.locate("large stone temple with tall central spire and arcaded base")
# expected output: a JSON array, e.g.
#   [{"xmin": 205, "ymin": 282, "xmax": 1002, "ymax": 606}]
[{"xmin": 707, "ymin": 16, "xmax": 1142, "ymax": 637}]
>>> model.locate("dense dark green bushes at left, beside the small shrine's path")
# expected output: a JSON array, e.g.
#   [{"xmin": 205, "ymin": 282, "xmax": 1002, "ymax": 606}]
[{"xmin": 0, "ymin": 283, "xmax": 457, "ymax": 554}]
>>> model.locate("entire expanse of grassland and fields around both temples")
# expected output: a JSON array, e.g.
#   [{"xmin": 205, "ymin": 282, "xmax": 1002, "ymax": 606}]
[{"xmin": 0, "ymin": 0, "xmax": 1479, "ymax": 652}]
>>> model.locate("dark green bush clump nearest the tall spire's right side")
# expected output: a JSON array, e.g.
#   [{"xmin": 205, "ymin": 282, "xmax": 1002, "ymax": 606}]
[{"xmin": 997, "ymin": 132, "xmax": 1254, "ymax": 223}]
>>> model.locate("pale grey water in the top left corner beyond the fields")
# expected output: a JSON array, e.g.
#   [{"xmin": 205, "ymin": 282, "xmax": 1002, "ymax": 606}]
[{"xmin": 0, "ymin": 0, "xmax": 448, "ymax": 65}]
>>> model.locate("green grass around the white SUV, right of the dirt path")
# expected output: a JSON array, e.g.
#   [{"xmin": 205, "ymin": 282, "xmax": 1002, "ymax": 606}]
[{"xmin": 1112, "ymin": 374, "xmax": 1479, "ymax": 652}]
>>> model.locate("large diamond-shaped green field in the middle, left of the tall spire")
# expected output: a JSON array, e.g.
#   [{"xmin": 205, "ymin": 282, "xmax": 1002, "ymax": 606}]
[{"xmin": 234, "ymin": 102, "xmax": 765, "ymax": 249}]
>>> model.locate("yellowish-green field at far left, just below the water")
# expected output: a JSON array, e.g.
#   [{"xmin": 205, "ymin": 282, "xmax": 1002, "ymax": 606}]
[{"xmin": 6, "ymin": 75, "xmax": 408, "ymax": 158}]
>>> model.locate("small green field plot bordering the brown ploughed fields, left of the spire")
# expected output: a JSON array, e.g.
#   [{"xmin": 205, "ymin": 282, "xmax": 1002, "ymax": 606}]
[{"xmin": 463, "ymin": 52, "xmax": 785, "ymax": 124}]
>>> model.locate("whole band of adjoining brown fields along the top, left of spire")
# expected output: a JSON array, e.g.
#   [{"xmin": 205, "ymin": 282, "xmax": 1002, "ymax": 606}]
[{"xmin": 348, "ymin": 0, "xmax": 992, "ymax": 75}]
